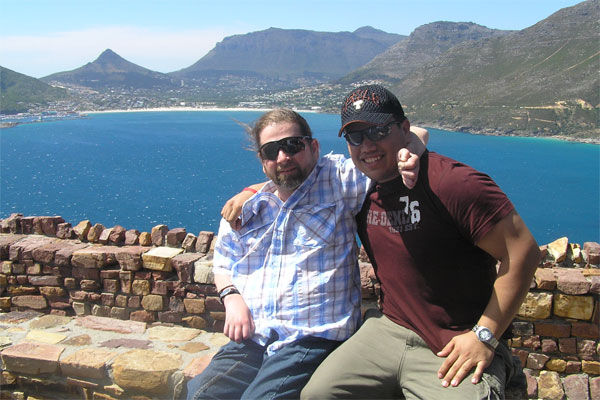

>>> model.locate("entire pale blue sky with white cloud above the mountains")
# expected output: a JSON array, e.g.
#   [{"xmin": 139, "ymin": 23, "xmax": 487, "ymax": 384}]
[{"xmin": 0, "ymin": 0, "xmax": 580, "ymax": 78}]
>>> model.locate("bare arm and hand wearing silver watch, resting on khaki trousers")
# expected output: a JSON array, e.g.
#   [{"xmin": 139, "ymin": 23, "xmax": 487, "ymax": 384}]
[{"xmin": 437, "ymin": 211, "xmax": 540, "ymax": 386}]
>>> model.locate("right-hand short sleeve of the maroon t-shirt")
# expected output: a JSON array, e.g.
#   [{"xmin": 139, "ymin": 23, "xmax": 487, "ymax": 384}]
[{"xmin": 438, "ymin": 162, "xmax": 514, "ymax": 244}]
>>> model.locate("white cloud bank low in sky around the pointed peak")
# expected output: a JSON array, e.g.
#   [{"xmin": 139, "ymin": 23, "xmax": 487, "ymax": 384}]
[{"xmin": 0, "ymin": 27, "xmax": 236, "ymax": 78}]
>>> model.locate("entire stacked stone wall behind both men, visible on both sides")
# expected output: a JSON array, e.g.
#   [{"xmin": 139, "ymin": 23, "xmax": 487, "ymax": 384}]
[{"xmin": 0, "ymin": 214, "xmax": 600, "ymax": 399}]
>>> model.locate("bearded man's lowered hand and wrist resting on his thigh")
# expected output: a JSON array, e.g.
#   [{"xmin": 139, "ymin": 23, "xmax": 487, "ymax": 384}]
[{"xmin": 215, "ymin": 274, "xmax": 254, "ymax": 343}]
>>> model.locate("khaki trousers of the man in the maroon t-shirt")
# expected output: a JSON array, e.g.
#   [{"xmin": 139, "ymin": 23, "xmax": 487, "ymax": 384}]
[{"xmin": 301, "ymin": 313, "xmax": 514, "ymax": 400}]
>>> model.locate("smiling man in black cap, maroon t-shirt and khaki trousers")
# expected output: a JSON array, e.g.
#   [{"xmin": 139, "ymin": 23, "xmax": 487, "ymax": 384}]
[{"xmin": 302, "ymin": 85, "xmax": 539, "ymax": 399}]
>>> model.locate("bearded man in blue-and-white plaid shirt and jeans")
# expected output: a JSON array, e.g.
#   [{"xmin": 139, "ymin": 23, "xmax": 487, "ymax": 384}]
[{"xmin": 187, "ymin": 109, "xmax": 424, "ymax": 399}]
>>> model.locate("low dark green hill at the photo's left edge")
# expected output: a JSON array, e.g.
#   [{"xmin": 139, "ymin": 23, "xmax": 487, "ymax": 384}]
[{"xmin": 0, "ymin": 66, "xmax": 69, "ymax": 114}]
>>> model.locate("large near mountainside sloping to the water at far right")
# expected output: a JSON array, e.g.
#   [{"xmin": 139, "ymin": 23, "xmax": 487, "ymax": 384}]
[{"xmin": 391, "ymin": 0, "xmax": 600, "ymax": 135}]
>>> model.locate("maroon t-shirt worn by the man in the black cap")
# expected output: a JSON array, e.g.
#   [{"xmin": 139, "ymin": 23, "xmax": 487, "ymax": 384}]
[{"xmin": 357, "ymin": 152, "xmax": 514, "ymax": 353}]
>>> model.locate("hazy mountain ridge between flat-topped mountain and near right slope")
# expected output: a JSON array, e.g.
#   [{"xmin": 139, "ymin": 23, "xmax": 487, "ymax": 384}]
[{"xmin": 340, "ymin": 21, "xmax": 511, "ymax": 83}]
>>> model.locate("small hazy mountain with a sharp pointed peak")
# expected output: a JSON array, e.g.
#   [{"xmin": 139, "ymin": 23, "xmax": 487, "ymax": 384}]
[{"xmin": 41, "ymin": 49, "xmax": 174, "ymax": 89}]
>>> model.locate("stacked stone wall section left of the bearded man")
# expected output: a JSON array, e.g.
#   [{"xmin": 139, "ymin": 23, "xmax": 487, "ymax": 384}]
[{"xmin": 0, "ymin": 214, "xmax": 224, "ymax": 330}]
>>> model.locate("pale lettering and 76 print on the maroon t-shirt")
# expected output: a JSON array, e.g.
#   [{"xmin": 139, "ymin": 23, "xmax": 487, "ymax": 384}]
[{"xmin": 367, "ymin": 196, "xmax": 421, "ymax": 233}]
